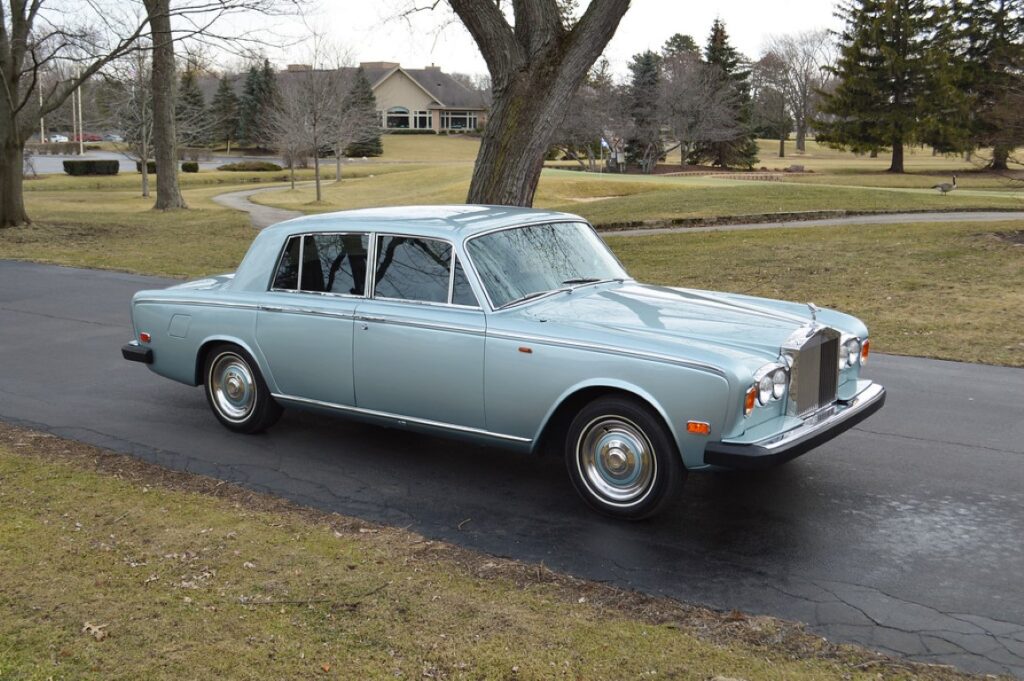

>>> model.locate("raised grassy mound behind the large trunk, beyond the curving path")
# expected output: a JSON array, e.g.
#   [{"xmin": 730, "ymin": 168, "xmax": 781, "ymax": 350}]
[{"xmin": 254, "ymin": 165, "xmax": 1024, "ymax": 226}]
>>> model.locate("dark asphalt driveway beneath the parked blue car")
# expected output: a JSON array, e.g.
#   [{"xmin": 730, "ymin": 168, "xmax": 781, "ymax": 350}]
[{"xmin": 6, "ymin": 261, "xmax": 1024, "ymax": 677}]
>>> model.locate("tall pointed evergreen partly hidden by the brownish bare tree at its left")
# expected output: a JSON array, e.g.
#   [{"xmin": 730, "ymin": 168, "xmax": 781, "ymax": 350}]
[{"xmin": 693, "ymin": 19, "xmax": 758, "ymax": 168}]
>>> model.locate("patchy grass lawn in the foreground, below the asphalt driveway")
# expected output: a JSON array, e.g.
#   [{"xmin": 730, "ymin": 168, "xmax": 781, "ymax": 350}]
[{"xmin": 0, "ymin": 424, "xmax": 987, "ymax": 681}]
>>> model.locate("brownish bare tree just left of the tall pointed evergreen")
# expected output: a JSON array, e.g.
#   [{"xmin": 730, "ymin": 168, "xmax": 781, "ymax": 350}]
[{"xmin": 660, "ymin": 53, "xmax": 742, "ymax": 166}]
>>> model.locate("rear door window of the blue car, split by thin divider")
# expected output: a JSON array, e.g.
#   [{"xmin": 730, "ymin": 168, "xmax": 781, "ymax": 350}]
[{"xmin": 273, "ymin": 235, "xmax": 370, "ymax": 296}]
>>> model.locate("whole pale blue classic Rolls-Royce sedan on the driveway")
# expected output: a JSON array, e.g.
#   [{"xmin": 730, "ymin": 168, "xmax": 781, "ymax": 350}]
[{"xmin": 122, "ymin": 206, "xmax": 886, "ymax": 518}]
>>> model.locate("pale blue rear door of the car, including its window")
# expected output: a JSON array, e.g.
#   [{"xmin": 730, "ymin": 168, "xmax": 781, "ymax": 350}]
[{"xmin": 256, "ymin": 232, "xmax": 369, "ymax": 407}]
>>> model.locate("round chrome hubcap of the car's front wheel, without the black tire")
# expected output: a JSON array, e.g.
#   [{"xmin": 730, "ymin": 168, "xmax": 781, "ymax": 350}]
[{"xmin": 577, "ymin": 417, "xmax": 656, "ymax": 506}]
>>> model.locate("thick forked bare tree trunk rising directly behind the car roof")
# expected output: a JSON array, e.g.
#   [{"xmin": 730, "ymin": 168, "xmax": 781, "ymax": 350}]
[{"xmin": 414, "ymin": 0, "xmax": 630, "ymax": 206}]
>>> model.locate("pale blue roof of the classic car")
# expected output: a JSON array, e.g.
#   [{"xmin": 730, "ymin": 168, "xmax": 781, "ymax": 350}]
[{"xmin": 260, "ymin": 205, "xmax": 584, "ymax": 239}]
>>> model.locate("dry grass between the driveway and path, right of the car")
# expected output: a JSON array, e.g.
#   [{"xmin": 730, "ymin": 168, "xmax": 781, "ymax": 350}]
[{"xmin": 607, "ymin": 222, "xmax": 1024, "ymax": 367}]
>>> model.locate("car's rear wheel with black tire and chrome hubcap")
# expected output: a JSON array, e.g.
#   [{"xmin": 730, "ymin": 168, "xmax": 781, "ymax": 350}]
[{"xmin": 203, "ymin": 344, "xmax": 282, "ymax": 433}]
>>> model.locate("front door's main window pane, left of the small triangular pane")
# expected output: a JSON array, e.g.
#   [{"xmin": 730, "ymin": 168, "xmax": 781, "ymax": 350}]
[{"xmin": 374, "ymin": 237, "xmax": 452, "ymax": 303}]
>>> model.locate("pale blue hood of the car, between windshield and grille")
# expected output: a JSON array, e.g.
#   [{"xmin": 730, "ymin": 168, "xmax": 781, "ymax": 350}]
[{"xmin": 503, "ymin": 282, "xmax": 859, "ymax": 369}]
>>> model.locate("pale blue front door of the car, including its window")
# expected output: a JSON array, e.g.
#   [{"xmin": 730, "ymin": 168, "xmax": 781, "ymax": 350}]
[{"xmin": 353, "ymin": 235, "xmax": 486, "ymax": 429}]
